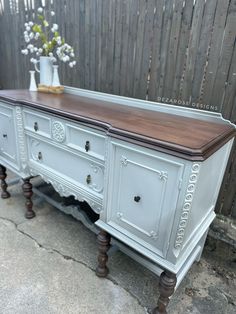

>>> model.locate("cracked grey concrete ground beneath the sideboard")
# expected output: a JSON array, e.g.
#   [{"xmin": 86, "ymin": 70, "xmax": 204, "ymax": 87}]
[{"xmin": 0, "ymin": 173, "xmax": 236, "ymax": 314}]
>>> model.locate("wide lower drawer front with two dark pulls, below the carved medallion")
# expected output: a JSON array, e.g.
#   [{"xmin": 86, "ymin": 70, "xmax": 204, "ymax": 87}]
[{"xmin": 27, "ymin": 137, "xmax": 104, "ymax": 196}]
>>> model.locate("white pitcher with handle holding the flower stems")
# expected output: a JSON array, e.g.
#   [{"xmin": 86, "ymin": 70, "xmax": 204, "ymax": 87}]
[{"xmin": 34, "ymin": 57, "xmax": 53, "ymax": 86}]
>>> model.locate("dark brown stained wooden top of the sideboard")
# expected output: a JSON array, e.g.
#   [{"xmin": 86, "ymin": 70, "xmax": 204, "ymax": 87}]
[{"xmin": 0, "ymin": 90, "xmax": 235, "ymax": 160}]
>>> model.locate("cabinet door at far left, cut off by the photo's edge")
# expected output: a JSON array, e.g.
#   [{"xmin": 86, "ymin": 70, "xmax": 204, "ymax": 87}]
[{"xmin": 0, "ymin": 103, "xmax": 17, "ymax": 165}]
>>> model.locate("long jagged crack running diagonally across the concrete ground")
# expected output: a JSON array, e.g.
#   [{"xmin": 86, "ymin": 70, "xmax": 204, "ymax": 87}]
[{"xmin": 0, "ymin": 216, "xmax": 146, "ymax": 313}]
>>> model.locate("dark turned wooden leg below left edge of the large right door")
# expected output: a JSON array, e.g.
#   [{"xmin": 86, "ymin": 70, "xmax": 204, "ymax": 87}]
[{"xmin": 96, "ymin": 230, "xmax": 111, "ymax": 277}]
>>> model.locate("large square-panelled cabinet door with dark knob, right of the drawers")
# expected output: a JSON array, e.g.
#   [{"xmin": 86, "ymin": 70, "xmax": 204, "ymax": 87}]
[{"xmin": 107, "ymin": 145, "xmax": 184, "ymax": 257}]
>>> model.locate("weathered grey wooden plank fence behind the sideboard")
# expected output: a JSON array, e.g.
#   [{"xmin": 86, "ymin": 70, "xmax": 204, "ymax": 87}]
[{"xmin": 0, "ymin": 0, "xmax": 236, "ymax": 217}]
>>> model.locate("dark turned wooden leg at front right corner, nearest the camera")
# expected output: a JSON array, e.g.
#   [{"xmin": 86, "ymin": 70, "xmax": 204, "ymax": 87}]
[{"xmin": 153, "ymin": 270, "xmax": 177, "ymax": 314}]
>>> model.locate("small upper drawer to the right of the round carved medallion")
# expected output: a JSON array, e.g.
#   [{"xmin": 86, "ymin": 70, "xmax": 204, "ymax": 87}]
[{"xmin": 67, "ymin": 125, "xmax": 105, "ymax": 160}]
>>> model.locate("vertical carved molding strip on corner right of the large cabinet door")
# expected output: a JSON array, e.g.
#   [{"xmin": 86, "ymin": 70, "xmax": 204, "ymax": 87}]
[{"xmin": 174, "ymin": 163, "xmax": 200, "ymax": 257}]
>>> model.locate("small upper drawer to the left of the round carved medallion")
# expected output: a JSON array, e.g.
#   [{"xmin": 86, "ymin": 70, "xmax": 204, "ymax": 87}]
[{"xmin": 23, "ymin": 110, "xmax": 51, "ymax": 138}]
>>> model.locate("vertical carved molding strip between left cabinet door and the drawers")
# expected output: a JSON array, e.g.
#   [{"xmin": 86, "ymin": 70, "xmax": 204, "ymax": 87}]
[{"xmin": 16, "ymin": 106, "xmax": 27, "ymax": 170}]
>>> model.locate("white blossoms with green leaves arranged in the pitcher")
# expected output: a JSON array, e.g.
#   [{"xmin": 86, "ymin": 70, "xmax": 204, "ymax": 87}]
[{"xmin": 21, "ymin": 7, "xmax": 76, "ymax": 68}]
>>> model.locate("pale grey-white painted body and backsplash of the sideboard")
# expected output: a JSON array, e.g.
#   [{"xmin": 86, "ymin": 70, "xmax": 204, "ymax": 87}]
[{"xmin": 0, "ymin": 88, "xmax": 233, "ymax": 290}]
